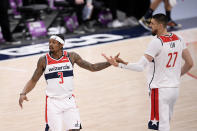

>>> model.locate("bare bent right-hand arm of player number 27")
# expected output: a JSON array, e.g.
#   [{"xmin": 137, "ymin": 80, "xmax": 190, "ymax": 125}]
[{"xmin": 181, "ymin": 49, "xmax": 193, "ymax": 76}]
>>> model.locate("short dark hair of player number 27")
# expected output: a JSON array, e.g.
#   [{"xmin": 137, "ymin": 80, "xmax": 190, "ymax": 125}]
[{"xmin": 152, "ymin": 13, "xmax": 168, "ymax": 27}]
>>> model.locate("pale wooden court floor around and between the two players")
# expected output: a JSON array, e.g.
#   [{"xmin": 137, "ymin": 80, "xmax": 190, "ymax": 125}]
[{"xmin": 0, "ymin": 29, "xmax": 197, "ymax": 131}]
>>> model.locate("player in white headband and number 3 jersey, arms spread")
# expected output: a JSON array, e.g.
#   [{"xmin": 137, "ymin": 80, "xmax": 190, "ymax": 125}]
[{"xmin": 19, "ymin": 35, "xmax": 110, "ymax": 131}]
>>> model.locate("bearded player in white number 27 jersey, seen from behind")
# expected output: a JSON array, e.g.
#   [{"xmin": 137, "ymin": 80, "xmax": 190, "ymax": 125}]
[{"xmin": 103, "ymin": 14, "xmax": 193, "ymax": 131}]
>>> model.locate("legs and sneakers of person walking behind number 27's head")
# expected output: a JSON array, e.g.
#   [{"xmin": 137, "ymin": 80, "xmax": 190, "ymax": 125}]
[{"xmin": 139, "ymin": 0, "xmax": 182, "ymax": 30}]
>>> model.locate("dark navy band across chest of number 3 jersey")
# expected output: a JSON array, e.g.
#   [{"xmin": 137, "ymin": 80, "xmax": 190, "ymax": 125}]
[{"xmin": 45, "ymin": 70, "xmax": 73, "ymax": 80}]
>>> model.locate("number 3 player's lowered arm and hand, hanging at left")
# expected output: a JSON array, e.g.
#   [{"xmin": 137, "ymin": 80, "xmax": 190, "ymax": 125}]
[{"xmin": 19, "ymin": 56, "xmax": 46, "ymax": 108}]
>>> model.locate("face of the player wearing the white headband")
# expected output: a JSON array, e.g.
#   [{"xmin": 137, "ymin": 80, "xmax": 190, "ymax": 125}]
[{"xmin": 49, "ymin": 39, "xmax": 62, "ymax": 53}]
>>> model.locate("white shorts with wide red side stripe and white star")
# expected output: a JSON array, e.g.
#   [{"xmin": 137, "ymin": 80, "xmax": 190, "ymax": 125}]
[{"xmin": 148, "ymin": 88, "xmax": 179, "ymax": 131}]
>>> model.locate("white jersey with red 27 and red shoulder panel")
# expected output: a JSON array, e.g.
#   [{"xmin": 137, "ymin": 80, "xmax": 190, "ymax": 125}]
[{"xmin": 145, "ymin": 33, "xmax": 186, "ymax": 88}]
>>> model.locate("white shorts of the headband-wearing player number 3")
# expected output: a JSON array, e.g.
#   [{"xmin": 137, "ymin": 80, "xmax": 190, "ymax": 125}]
[{"xmin": 45, "ymin": 96, "xmax": 81, "ymax": 131}]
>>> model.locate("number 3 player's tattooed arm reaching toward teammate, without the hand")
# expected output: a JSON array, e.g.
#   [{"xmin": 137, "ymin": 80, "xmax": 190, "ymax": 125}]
[{"xmin": 69, "ymin": 52, "xmax": 111, "ymax": 72}]
